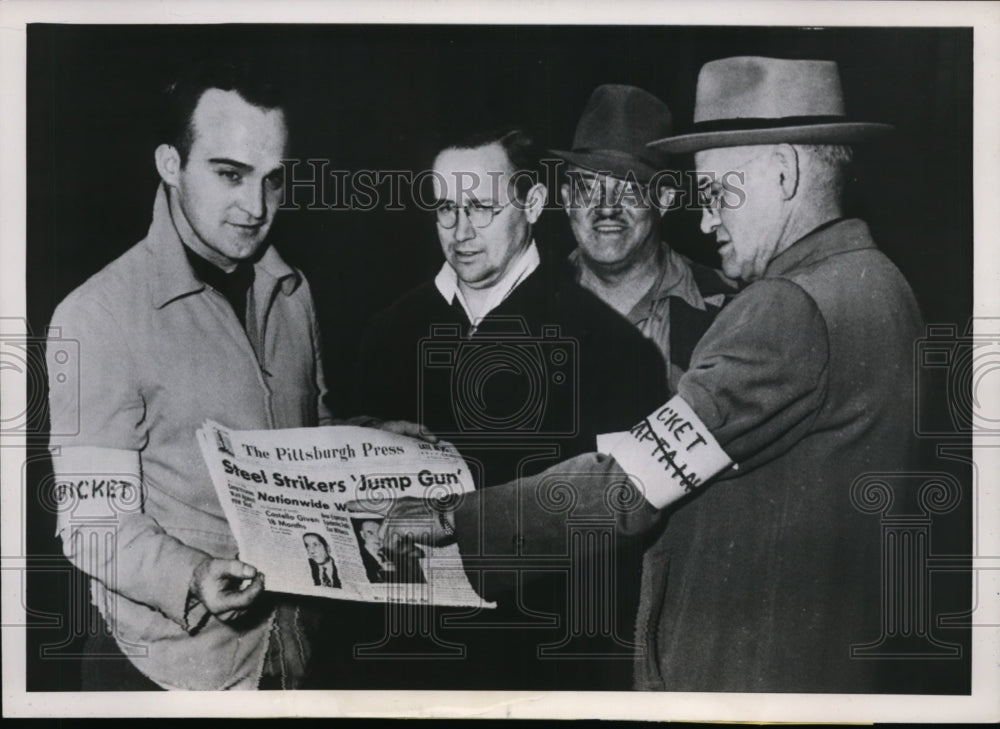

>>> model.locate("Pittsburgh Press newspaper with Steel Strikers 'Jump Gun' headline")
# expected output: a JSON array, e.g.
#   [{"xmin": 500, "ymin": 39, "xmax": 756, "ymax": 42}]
[{"xmin": 198, "ymin": 421, "xmax": 495, "ymax": 607}]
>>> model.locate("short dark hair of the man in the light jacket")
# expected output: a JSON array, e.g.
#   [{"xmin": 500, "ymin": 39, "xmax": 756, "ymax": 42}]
[{"xmin": 159, "ymin": 59, "xmax": 285, "ymax": 164}]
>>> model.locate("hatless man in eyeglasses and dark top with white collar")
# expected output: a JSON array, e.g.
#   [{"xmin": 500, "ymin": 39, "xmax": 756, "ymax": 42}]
[{"xmin": 360, "ymin": 127, "xmax": 667, "ymax": 689}]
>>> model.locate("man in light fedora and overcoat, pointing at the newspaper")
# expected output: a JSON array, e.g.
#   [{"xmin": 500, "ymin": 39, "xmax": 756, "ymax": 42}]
[{"xmin": 387, "ymin": 57, "xmax": 922, "ymax": 693}]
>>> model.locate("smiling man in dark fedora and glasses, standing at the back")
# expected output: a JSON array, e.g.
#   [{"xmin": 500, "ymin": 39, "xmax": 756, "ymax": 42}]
[{"xmin": 551, "ymin": 84, "xmax": 734, "ymax": 387}]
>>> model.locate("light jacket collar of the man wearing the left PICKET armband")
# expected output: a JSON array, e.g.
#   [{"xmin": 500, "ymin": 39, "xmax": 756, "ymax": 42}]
[{"xmin": 145, "ymin": 183, "xmax": 301, "ymax": 309}]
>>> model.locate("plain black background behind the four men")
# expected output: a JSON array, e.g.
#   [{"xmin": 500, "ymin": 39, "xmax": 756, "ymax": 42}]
[{"xmin": 25, "ymin": 24, "xmax": 973, "ymax": 693}]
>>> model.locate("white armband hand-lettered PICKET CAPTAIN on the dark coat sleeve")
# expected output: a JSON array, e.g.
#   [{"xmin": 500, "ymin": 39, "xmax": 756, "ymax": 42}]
[{"xmin": 597, "ymin": 395, "xmax": 732, "ymax": 509}]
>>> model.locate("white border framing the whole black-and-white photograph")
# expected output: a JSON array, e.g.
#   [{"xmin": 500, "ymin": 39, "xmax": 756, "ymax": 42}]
[{"xmin": 0, "ymin": 0, "xmax": 1000, "ymax": 722}]
